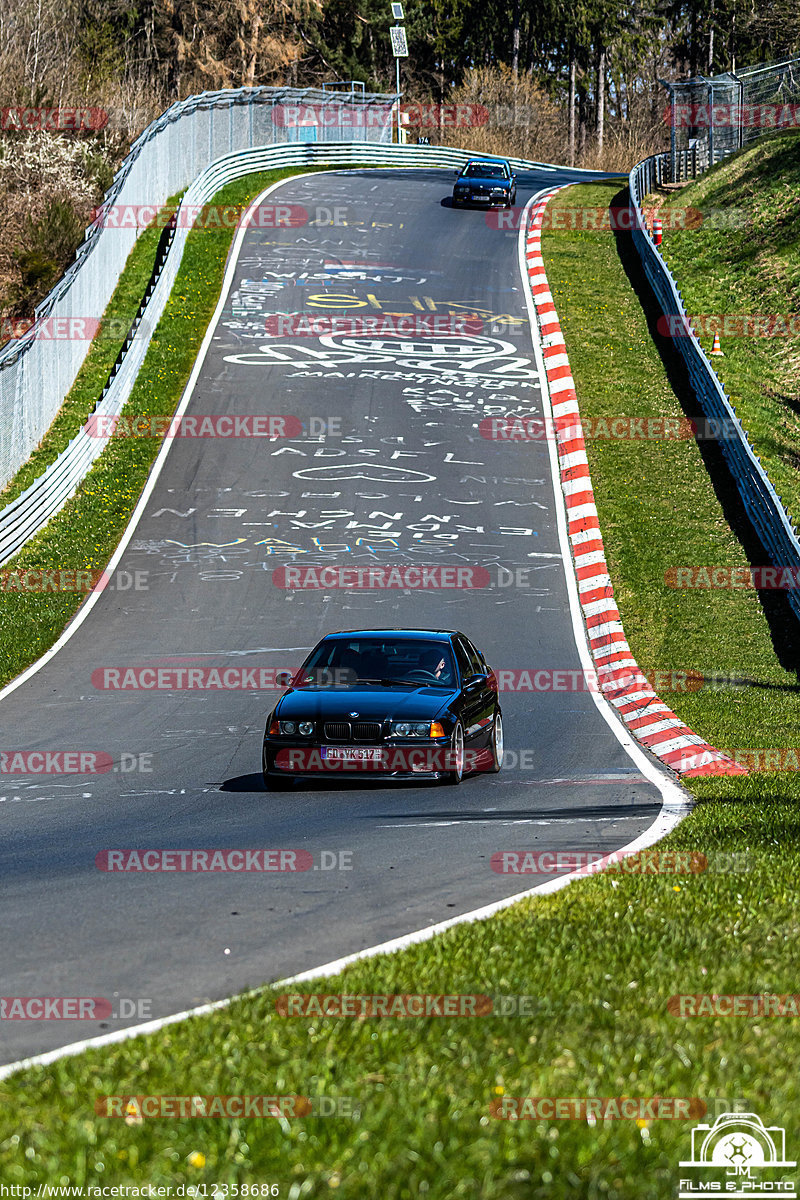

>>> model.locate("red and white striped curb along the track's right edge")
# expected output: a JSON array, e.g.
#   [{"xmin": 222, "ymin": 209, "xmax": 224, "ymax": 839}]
[{"xmin": 525, "ymin": 185, "xmax": 747, "ymax": 775}]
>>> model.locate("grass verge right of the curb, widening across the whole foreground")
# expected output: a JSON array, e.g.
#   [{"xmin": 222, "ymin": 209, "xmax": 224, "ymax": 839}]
[{"xmin": 0, "ymin": 186, "xmax": 800, "ymax": 1200}]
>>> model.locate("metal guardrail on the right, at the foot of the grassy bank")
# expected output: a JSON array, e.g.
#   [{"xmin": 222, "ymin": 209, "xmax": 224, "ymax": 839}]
[{"xmin": 628, "ymin": 155, "xmax": 800, "ymax": 617}]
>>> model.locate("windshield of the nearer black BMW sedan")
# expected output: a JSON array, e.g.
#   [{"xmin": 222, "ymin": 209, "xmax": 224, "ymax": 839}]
[{"xmin": 294, "ymin": 637, "xmax": 456, "ymax": 688}]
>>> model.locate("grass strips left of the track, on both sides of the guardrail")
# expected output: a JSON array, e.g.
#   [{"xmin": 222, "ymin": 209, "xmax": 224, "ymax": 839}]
[{"xmin": 0, "ymin": 168, "xmax": 340, "ymax": 684}]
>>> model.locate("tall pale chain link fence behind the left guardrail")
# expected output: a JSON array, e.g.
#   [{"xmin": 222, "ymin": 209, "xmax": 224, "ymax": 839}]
[{"xmin": 0, "ymin": 88, "xmax": 398, "ymax": 487}]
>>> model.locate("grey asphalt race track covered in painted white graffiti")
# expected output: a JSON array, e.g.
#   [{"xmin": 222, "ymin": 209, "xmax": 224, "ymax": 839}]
[{"xmin": 0, "ymin": 170, "xmax": 661, "ymax": 1062}]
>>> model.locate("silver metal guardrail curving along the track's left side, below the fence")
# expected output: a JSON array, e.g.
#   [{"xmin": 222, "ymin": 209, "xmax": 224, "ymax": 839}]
[{"xmin": 0, "ymin": 142, "xmax": 575, "ymax": 563}]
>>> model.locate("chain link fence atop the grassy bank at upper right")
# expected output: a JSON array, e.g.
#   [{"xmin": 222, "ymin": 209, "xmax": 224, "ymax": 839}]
[{"xmin": 661, "ymin": 58, "xmax": 800, "ymax": 182}]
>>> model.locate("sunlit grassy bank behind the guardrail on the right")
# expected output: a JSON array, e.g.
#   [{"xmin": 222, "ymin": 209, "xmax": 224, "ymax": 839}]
[{"xmin": 662, "ymin": 132, "xmax": 800, "ymax": 521}]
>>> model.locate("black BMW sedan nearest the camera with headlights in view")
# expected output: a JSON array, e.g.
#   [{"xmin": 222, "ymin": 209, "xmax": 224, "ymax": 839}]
[{"xmin": 261, "ymin": 629, "xmax": 503, "ymax": 791}]
